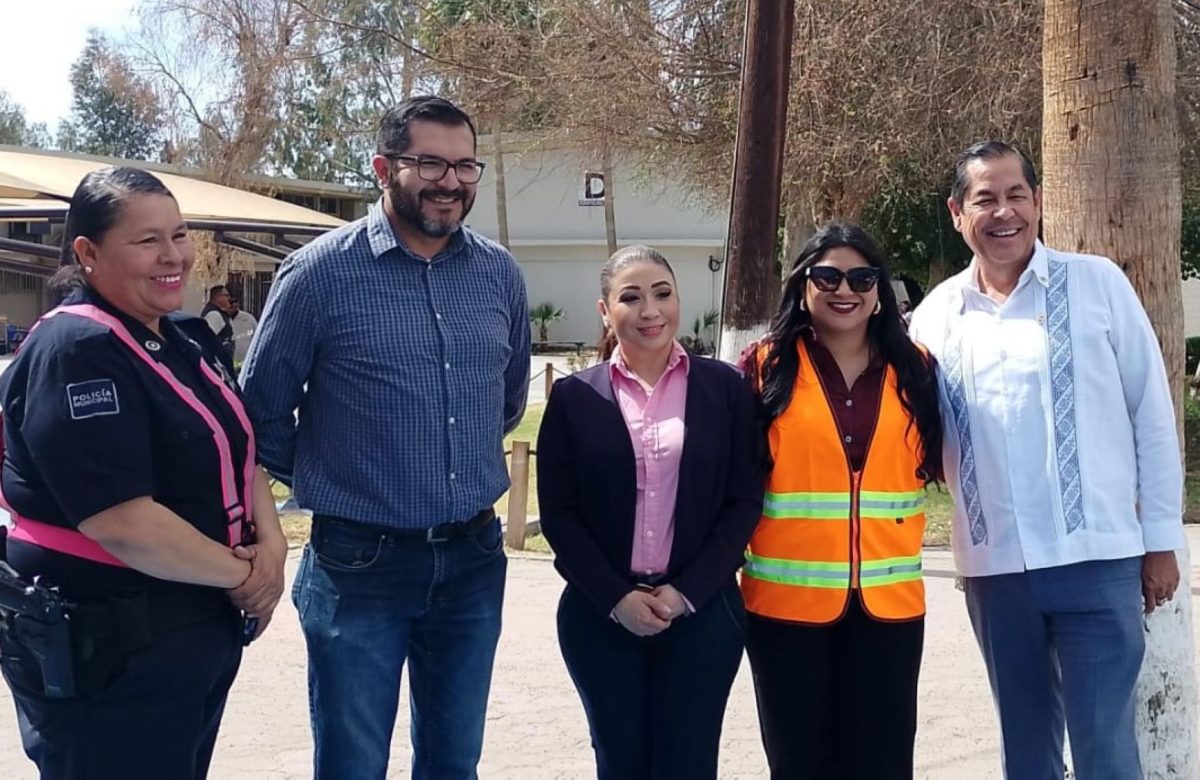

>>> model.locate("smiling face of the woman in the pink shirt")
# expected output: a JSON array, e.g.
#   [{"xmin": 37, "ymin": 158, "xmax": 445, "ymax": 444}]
[{"xmin": 596, "ymin": 260, "xmax": 679, "ymax": 361}]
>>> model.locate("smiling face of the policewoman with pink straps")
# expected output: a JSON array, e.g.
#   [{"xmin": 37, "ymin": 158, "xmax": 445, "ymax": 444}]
[{"xmin": 73, "ymin": 194, "xmax": 196, "ymax": 329}]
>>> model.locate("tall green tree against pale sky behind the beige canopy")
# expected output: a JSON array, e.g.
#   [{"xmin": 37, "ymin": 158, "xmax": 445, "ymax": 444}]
[{"xmin": 59, "ymin": 31, "xmax": 162, "ymax": 160}]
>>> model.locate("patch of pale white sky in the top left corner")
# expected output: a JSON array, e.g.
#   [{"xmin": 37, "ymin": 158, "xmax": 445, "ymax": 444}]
[{"xmin": 0, "ymin": 0, "xmax": 137, "ymax": 134}]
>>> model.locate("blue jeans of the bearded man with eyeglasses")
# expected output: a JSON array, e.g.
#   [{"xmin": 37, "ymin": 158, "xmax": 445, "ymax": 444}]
[{"xmin": 292, "ymin": 516, "xmax": 508, "ymax": 780}]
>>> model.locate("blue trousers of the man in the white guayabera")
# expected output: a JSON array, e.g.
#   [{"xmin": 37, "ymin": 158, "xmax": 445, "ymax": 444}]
[{"xmin": 965, "ymin": 557, "xmax": 1146, "ymax": 780}]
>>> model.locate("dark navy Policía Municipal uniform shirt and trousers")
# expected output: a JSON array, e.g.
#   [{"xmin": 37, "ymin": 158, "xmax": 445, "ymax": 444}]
[{"xmin": 0, "ymin": 289, "xmax": 248, "ymax": 779}]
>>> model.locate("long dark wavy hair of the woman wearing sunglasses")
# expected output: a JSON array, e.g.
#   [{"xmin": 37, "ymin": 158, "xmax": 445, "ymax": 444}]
[{"xmin": 749, "ymin": 222, "xmax": 942, "ymax": 484}]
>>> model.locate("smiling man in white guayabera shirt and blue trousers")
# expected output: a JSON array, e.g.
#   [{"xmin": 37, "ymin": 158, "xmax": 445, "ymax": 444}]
[{"xmin": 911, "ymin": 142, "xmax": 1184, "ymax": 780}]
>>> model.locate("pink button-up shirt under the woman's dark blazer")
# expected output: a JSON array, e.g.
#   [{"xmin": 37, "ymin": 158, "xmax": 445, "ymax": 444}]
[{"xmin": 608, "ymin": 342, "xmax": 690, "ymax": 575}]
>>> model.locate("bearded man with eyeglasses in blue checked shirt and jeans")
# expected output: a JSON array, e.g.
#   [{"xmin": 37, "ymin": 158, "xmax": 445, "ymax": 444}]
[{"xmin": 242, "ymin": 97, "xmax": 530, "ymax": 780}]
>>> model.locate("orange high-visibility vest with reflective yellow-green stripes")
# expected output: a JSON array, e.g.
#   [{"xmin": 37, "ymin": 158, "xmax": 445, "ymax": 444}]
[{"xmin": 742, "ymin": 342, "xmax": 925, "ymax": 624}]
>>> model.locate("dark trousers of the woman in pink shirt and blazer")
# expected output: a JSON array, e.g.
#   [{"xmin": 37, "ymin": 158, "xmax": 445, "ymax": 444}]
[{"xmin": 558, "ymin": 578, "xmax": 745, "ymax": 780}]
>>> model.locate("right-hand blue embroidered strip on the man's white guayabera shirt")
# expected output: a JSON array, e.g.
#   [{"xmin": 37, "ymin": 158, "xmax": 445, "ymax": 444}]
[{"xmin": 1046, "ymin": 262, "xmax": 1084, "ymax": 534}]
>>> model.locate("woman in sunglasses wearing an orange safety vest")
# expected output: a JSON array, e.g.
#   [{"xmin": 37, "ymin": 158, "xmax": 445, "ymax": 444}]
[{"xmin": 742, "ymin": 223, "xmax": 942, "ymax": 780}]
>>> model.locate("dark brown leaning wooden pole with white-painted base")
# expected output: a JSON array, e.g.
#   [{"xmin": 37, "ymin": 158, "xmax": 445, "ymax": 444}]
[{"xmin": 720, "ymin": 0, "xmax": 796, "ymax": 360}]
